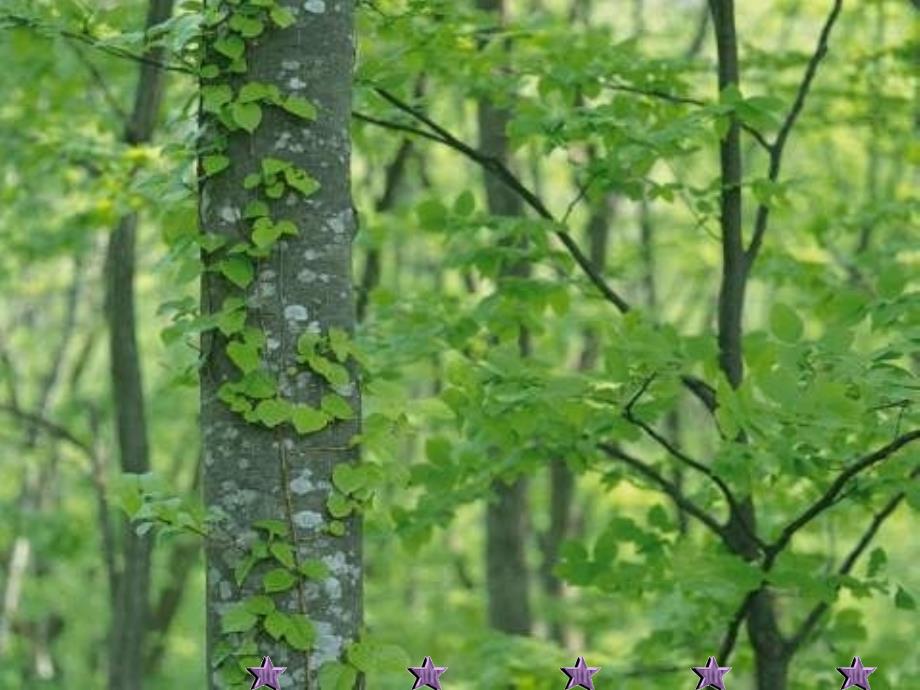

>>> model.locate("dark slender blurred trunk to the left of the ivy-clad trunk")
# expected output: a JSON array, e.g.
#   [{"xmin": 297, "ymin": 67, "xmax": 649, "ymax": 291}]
[{"xmin": 106, "ymin": 0, "xmax": 173, "ymax": 690}]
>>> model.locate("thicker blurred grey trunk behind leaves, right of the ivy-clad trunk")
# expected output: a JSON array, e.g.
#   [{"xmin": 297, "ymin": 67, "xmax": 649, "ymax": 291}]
[{"xmin": 477, "ymin": 0, "xmax": 532, "ymax": 635}]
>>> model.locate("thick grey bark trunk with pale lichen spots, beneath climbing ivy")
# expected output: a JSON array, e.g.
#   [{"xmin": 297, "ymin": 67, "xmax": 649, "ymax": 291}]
[{"xmin": 199, "ymin": 0, "xmax": 362, "ymax": 690}]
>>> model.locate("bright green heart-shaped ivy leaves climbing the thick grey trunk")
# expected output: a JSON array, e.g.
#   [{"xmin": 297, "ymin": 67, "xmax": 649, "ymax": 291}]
[{"xmin": 199, "ymin": 0, "xmax": 393, "ymax": 690}]
